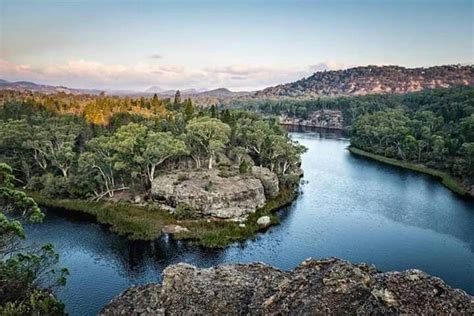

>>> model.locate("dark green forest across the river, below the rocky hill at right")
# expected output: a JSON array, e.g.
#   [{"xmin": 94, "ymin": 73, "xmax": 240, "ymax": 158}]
[{"xmin": 234, "ymin": 86, "xmax": 474, "ymax": 191}]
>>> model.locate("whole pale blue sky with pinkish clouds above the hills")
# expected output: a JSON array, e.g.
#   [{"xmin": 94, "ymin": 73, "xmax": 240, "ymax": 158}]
[{"xmin": 0, "ymin": 0, "xmax": 474, "ymax": 91}]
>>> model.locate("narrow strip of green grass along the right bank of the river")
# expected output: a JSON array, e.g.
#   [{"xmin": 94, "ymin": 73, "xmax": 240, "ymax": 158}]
[{"xmin": 348, "ymin": 146, "xmax": 466, "ymax": 196}]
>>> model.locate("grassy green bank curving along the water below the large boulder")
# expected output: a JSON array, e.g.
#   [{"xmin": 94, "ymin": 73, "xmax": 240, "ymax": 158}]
[{"xmin": 28, "ymin": 187, "xmax": 297, "ymax": 248}]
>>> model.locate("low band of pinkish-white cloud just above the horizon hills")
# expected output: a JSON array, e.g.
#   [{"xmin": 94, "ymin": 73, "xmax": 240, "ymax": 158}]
[{"xmin": 0, "ymin": 59, "xmax": 344, "ymax": 90}]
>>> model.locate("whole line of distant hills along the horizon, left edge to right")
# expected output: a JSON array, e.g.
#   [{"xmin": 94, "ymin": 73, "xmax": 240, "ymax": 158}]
[{"xmin": 0, "ymin": 65, "xmax": 474, "ymax": 104}]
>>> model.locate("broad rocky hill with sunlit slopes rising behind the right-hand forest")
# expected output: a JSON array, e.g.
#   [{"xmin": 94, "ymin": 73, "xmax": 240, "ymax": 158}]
[{"xmin": 254, "ymin": 65, "xmax": 474, "ymax": 99}]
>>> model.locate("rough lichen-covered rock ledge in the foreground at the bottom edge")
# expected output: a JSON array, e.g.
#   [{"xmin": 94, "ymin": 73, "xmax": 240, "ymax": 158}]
[{"xmin": 101, "ymin": 258, "xmax": 474, "ymax": 315}]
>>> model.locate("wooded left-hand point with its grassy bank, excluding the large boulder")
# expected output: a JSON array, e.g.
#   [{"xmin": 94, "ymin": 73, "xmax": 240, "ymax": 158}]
[{"xmin": 0, "ymin": 91, "xmax": 304, "ymax": 246}]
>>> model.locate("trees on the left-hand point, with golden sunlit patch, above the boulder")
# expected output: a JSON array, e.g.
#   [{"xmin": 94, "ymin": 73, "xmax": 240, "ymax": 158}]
[{"xmin": 0, "ymin": 92, "xmax": 303, "ymax": 200}]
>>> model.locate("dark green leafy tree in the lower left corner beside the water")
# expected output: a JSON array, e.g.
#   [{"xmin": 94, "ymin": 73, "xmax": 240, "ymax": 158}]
[{"xmin": 0, "ymin": 163, "xmax": 68, "ymax": 315}]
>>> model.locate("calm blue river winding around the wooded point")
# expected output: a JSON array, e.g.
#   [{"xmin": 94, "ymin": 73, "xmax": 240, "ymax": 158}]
[{"xmin": 22, "ymin": 132, "xmax": 474, "ymax": 315}]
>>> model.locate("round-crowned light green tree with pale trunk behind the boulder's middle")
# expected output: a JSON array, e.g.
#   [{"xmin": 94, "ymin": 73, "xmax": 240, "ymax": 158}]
[{"xmin": 186, "ymin": 117, "xmax": 230, "ymax": 169}]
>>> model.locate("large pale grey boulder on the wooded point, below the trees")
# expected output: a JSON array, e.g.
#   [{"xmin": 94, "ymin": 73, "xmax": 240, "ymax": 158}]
[{"xmin": 151, "ymin": 170, "xmax": 266, "ymax": 219}]
